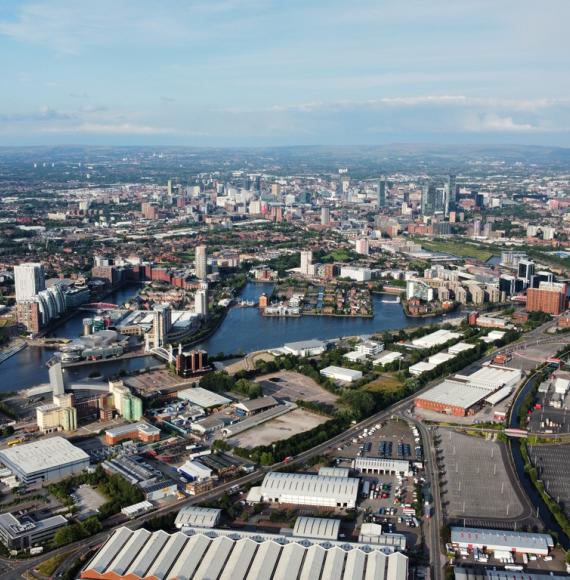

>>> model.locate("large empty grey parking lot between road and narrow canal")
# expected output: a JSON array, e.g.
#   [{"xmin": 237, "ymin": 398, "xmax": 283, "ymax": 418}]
[{"xmin": 436, "ymin": 428, "xmax": 523, "ymax": 523}]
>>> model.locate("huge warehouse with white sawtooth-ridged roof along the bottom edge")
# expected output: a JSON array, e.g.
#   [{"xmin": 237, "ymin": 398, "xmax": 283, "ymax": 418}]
[{"xmin": 80, "ymin": 527, "xmax": 408, "ymax": 580}]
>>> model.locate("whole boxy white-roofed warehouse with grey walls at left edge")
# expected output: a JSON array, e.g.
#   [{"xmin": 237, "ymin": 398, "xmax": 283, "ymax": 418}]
[{"xmin": 0, "ymin": 437, "xmax": 89, "ymax": 485}]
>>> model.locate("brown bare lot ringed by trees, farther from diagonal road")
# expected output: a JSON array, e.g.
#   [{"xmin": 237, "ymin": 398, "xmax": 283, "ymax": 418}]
[{"xmin": 256, "ymin": 371, "xmax": 337, "ymax": 405}]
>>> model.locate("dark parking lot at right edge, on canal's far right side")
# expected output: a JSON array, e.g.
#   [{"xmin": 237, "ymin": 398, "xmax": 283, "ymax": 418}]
[{"xmin": 529, "ymin": 445, "xmax": 570, "ymax": 517}]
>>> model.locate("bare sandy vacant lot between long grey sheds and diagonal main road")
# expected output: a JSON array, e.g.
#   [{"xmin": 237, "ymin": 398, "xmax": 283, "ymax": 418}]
[{"xmin": 228, "ymin": 409, "xmax": 328, "ymax": 449}]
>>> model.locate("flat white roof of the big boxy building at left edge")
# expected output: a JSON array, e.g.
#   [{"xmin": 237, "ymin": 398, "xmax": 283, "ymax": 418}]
[{"xmin": 0, "ymin": 437, "xmax": 89, "ymax": 475}]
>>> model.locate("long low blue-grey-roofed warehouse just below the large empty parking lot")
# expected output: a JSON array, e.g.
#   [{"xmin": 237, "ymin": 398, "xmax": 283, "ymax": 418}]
[{"xmin": 451, "ymin": 527, "xmax": 554, "ymax": 556}]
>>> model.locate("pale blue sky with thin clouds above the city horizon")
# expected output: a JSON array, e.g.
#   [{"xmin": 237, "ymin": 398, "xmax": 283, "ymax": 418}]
[{"xmin": 0, "ymin": 0, "xmax": 570, "ymax": 147}]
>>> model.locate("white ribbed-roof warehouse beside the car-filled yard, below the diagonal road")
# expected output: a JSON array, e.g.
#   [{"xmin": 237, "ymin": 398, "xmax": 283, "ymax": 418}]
[{"xmin": 248, "ymin": 472, "xmax": 359, "ymax": 509}]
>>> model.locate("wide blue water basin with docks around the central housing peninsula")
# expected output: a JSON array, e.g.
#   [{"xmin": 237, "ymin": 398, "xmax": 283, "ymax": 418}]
[{"xmin": 199, "ymin": 282, "xmax": 456, "ymax": 355}]
